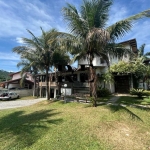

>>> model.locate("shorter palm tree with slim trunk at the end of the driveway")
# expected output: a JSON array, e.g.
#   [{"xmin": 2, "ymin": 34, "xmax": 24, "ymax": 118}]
[{"xmin": 13, "ymin": 28, "xmax": 69, "ymax": 100}]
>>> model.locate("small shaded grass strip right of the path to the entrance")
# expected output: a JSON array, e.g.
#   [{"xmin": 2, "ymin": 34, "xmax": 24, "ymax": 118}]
[{"xmin": 117, "ymin": 96, "xmax": 150, "ymax": 105}]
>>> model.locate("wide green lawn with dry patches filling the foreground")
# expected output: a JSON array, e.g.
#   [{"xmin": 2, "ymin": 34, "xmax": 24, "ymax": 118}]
[{"xmin": 0, "ymin": 101, "xmax": 150, "ymax": 150}]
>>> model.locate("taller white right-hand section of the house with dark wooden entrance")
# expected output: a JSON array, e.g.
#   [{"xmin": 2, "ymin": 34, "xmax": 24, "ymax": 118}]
[{"xmin": 78, "ymin": 39, "xmax": 137, "ymax": 93}]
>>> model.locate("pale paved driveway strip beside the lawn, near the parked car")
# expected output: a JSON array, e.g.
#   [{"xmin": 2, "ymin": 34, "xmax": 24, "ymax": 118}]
[{"xmin": 0, "ymin": 98, "xmax": 46, "ymax": 110}]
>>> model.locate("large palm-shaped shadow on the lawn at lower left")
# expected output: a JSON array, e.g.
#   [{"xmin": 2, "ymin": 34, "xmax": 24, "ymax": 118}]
[{"xmin": 0, "ymin": 110, "xmax": 63, "ymax": 149}]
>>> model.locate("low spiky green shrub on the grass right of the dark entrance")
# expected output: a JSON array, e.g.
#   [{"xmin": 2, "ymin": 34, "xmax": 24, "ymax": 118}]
[{"xmin": 130, "ymin": 88, "xmax": 150, "ymax": 98}]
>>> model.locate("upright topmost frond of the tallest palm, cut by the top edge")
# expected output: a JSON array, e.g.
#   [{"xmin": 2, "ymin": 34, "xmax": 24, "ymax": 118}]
[{"xmin": 81, "ymin": 0, "xmax": 112, "ymax": 29}]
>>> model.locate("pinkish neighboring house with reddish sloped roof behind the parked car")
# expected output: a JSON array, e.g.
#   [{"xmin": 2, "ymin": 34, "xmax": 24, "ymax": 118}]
[{"xmin": 5, "ymin": 71, "xmax": 34, "ymax": 90}]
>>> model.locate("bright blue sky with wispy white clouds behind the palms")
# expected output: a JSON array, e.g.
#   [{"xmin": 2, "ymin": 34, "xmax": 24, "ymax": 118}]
[{"xmin": 0, "ymin": 0, "xmax": 150, "ymax": 71}]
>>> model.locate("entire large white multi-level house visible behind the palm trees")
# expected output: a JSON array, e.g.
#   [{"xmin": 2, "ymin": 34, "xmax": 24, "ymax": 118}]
[{"xmin": 36, "ymin": 39, "xmax": 137, "ymax": 98}]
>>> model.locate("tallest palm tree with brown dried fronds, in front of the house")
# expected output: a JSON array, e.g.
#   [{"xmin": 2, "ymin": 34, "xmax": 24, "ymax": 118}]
[{"xmin": 62, "ymin": 0, "xmax": 150, "ymax": 106}]
